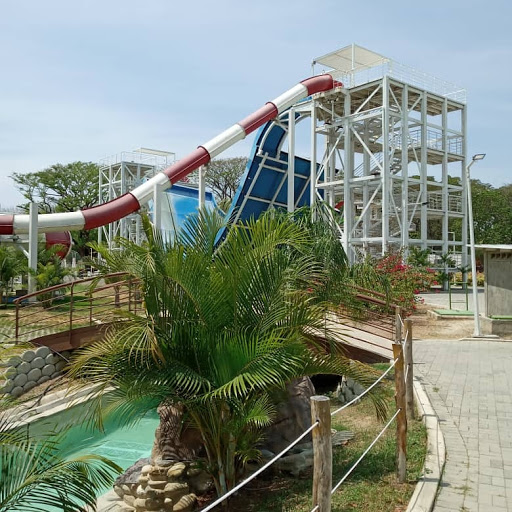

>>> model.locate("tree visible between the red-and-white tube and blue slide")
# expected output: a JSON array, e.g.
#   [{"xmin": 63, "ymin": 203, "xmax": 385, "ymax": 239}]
[{"xmin": 205, "ymin": 157, "xmax": 248, "ymax": 211}]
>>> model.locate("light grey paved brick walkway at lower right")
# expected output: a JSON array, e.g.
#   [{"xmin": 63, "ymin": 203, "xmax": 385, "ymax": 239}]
[{"xmin": 414, "ymin": 340, "xmax": 512, "ymax": 512}]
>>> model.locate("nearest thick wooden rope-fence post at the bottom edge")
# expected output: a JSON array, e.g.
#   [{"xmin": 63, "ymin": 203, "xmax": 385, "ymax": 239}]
[{"xmin": 311, "ymin": 396, "xmax": 332, "ymax": 512}]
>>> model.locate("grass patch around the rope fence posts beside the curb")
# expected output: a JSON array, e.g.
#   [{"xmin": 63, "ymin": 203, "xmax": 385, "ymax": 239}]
[{"xmin": 200, "ymin": 372, "xmax": 426, "ymax": 512}]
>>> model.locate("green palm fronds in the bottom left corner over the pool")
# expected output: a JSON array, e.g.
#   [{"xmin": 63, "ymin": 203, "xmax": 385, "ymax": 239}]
[{"xmin": 0, "ymin": 347, "xmax": 122, "ymax": 512}]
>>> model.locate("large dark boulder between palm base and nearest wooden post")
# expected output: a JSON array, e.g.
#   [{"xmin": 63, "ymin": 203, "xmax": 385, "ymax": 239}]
[{"xmin": 263, "ymin": 377, "xmax": 315, "ymax": 453}]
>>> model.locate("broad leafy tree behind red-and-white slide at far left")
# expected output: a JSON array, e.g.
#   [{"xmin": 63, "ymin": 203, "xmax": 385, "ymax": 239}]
[{"xmin": 11, "ymin": 162, "xmax": 99, "ymax": 256}]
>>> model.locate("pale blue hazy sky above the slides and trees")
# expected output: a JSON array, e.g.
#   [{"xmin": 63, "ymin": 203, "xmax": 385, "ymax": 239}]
[{"xmin": 0, "ymin": 0, "xmax": 512, "ymax": 208}]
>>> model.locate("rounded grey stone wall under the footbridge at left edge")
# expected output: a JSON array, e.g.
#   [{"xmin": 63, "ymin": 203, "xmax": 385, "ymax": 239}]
[{"xmin": 0, "ymin": 347, "xmax": 70, "ymax": 398}]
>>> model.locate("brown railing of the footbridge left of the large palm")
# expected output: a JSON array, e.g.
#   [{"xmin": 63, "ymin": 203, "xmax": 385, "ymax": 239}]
[{"xmin": 12, "ymin": 273, "xmax": 142, "ymax": 344}]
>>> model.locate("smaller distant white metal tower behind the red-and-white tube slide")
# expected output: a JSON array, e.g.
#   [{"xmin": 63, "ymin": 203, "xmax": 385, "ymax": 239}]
[{"xmin": 98, "ymin": 148, "xmax": 175, "ymax": 250}]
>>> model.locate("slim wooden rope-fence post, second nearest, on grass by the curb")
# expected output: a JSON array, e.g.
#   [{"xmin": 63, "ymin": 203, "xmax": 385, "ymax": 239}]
[{"xmin": 393, "ymin": 343, "xmax": 407, "ymax": 484}]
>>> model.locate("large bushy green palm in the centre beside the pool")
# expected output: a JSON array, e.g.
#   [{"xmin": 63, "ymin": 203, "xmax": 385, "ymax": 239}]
[{"xmin": 71, "ymin": 211, "xmax": 381, "ymax": 493}]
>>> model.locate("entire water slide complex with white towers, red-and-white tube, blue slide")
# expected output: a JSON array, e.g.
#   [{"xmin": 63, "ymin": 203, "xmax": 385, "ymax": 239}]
[{"xmin": 0, "ymin": 45, "xmax": 467, "ymax": 265}]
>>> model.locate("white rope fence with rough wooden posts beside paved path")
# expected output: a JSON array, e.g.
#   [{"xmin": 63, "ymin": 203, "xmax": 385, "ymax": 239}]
[{"xmin": 201, "ymin": 318, "xmax": 414, "ymax": 512}]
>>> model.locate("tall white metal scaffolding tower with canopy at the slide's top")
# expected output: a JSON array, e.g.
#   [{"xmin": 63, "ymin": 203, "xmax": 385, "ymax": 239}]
[{"xmin": 290, "ymin": 45, "xmax": 467, "ymax": 265}]
